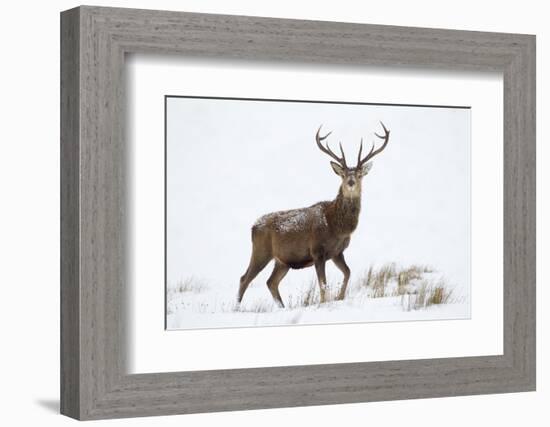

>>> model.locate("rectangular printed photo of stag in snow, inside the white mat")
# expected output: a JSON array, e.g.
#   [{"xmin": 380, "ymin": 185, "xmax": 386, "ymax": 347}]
[{"xmin": 165, "ymin": 95, "xmax": 471, "ymax": 330}]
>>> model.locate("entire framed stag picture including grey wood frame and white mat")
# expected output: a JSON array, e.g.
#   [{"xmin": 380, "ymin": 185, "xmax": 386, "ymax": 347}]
[{"xmin": 61, "ymin": 6, "xmax": 536, "ymax": 420}]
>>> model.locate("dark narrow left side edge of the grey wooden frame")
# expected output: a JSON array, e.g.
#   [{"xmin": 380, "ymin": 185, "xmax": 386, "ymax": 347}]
[{"xmin": 60, "ymin": 10, "xmax": 80, "ymax": 417}]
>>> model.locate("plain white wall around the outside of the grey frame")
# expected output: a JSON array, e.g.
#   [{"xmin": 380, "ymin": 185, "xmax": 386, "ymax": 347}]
[{"xmin": 0, "ymin": 0, "xmax": 550, "ymax": 427}]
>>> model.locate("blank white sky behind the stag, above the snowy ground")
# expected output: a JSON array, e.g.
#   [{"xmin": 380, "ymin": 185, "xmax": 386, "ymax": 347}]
[{"xmin": 166, "ymin": 97, "xmax": 470, "ymax": 294}]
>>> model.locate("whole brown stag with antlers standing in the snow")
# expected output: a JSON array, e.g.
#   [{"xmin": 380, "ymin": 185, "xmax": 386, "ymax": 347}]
[{"xmin": 237, "ymin": 122, "xmax": 390, "ymax": 308}]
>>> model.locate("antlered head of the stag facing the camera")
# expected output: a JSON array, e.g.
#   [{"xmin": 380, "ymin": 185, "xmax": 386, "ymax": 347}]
[{"xmin": 315, "ymin": 122, "xmax": 390, "ymax": 197}]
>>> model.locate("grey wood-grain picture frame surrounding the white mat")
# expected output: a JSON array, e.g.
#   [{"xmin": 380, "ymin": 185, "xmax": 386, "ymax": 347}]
[{"xmin": 61, "ymin": 6, "xmax": 535, "ymax": 419}]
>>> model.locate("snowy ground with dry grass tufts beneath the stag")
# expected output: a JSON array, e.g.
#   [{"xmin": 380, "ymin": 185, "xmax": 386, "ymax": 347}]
[{"xmin": 167, "ymin": 266, "xmax": 470, "ymax": 329}]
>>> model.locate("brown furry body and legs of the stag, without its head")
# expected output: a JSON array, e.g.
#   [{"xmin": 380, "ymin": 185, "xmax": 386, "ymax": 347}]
[{"xmin": 238, "ymin": 184, "xmax": 361, "ymax": 306}]
